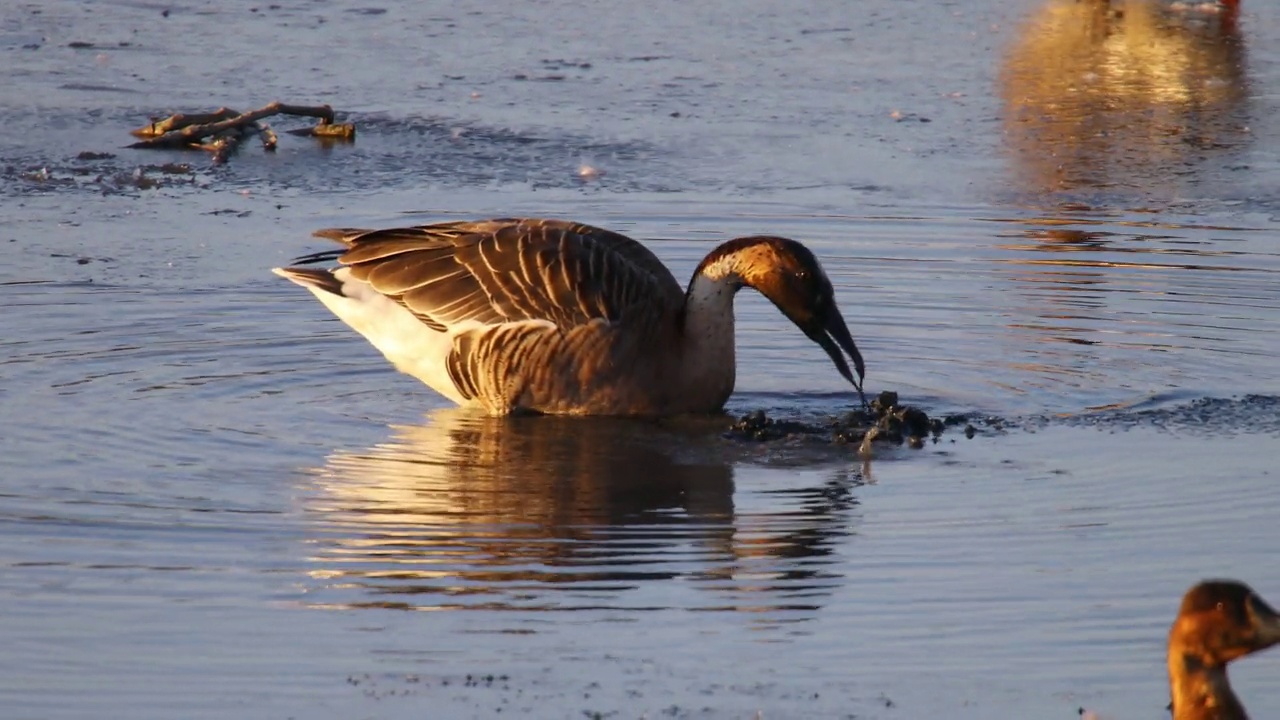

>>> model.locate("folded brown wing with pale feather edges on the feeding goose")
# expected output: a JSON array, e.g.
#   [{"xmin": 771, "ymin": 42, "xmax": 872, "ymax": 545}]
[{"xmin": 300, "ymin": 218, "xmax": 684, "ymax": 332}]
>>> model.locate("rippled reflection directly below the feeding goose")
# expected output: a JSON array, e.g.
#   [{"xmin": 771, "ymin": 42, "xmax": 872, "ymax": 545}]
[{"xmin": 299, "ymin": 409, "xmax": 856, "ymax": 620}]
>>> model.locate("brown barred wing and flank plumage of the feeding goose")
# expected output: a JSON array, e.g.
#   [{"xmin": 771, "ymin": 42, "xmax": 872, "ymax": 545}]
[{"xmin": 295, "ymin": 219, "xmax": 684, "ymax": 413}]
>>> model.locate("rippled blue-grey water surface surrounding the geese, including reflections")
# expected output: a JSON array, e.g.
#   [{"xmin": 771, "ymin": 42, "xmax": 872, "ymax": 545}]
[{"xmin": 0, "ymin": 0, "xmax": 1280, "ymax": 717}]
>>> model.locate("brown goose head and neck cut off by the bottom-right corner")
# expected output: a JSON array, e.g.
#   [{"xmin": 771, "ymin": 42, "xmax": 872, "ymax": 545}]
[{"xmin": 1169, "ymin": 580, "xmax": 1280, "ymax": 720}]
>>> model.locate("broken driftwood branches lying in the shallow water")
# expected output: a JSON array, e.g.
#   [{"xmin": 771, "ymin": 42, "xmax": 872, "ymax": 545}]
[{"xmin": 129, "ymin": 101, "xmax": 356, "ymax": 163}]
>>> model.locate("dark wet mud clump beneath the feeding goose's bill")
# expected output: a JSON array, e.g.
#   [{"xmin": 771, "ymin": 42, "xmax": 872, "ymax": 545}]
[{"xmin": 724, "ymin": 391, "xmax": 975, "ymax": 448}]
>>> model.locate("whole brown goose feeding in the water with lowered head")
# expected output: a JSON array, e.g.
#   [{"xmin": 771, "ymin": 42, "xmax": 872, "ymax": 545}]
[{"xmin": 274, "ymin": 219, "xmax": 865, "ymax": 415}]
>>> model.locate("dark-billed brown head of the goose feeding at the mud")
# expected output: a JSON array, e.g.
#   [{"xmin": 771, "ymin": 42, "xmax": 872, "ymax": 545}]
[{"xmin": 699, "ymin": 236, "xmax": 867, "ymax": 405}]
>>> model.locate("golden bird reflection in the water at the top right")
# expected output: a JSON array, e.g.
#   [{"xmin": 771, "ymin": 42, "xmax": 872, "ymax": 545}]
[{"xmin": 1000, "ymin": 0, "xmax": 1252, "ymax": 199}]
